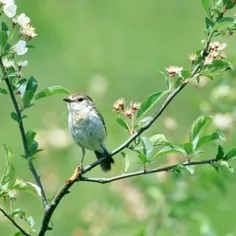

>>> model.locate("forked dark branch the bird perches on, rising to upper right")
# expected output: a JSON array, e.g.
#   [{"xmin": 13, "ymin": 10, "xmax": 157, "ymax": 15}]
[{"xmin": 38, "ymin": 9, "xmax": 227, "ymax": 236}]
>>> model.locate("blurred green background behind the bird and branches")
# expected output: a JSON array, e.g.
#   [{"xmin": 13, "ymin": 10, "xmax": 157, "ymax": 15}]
[{"xmin": 0, "ymin": 0, "xmax": 236, "ymax": 236}]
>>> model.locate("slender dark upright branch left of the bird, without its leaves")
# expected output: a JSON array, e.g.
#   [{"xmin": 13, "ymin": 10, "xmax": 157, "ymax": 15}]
[{"xmin": 0, "ymin": 57, "xmax": 48, "ymax": 208}]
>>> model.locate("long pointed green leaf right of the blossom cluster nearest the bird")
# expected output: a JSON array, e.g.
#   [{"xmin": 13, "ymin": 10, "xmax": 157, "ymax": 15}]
[{"xmin": 136, "ymin": 91, "xmax": 168, "ymax": 119}]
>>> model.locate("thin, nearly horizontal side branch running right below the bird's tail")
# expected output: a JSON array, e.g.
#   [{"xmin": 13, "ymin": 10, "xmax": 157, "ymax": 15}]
[{"xmin": 79, "ymin": 158, "xmax": 216, "ymax": 184}]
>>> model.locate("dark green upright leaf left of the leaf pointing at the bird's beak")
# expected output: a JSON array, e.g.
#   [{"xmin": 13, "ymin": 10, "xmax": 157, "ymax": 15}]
[{"xmin": 23, "ymin": 76, "xmax": 38, "ymax": 107}]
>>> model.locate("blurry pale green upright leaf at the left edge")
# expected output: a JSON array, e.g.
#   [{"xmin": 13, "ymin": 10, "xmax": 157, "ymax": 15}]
[{"xmin": 0, "ymin": 144, "xmax": 15, "ymax": 185}]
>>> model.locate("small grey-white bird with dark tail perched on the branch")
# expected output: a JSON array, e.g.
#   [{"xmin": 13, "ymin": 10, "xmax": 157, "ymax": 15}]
[{"xmin": 63, "ymin": 93, "xmax": 114, "ymax": 172}]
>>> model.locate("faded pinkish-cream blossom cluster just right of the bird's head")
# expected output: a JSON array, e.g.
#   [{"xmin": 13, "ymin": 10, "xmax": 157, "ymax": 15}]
[{"xmin": 113, "ymin": 98, "xmax": 140, "ymax": 119}]
